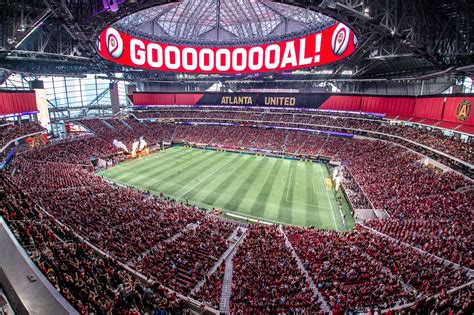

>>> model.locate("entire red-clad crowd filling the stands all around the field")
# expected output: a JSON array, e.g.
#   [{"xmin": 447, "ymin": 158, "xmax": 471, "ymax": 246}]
[{"xmin": 0, "ymin": 113, "xmax": 473, "ymax": 313}]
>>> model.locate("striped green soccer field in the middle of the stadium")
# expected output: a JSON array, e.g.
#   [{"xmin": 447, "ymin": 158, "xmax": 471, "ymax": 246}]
[{"xmin": 100, "ymin": 147, "xmax": 354, "ymax": 230}]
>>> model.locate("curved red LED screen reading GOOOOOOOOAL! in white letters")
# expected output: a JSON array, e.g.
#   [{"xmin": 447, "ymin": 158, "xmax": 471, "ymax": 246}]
[{"xmin": 96, "ymin": 23, "xmax": 357, "ymax": 74}]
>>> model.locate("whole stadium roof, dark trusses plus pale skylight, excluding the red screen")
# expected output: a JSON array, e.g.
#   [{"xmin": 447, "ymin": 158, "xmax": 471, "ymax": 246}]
[{"xmin": 0, "ymin": 0, "xmax": 474, "ymax": 82}]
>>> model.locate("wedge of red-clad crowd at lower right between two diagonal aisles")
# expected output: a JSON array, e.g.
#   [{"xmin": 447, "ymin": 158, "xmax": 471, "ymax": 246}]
[{"xmin": 285, "ymin": 227, "xmax": 469, "ymax": 314}]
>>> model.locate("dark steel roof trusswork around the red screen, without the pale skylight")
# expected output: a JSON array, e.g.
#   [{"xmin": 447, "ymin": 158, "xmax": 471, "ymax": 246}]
[{"xmin": 0, "ymin": 0, "xmax": 474, "ymax": 81}]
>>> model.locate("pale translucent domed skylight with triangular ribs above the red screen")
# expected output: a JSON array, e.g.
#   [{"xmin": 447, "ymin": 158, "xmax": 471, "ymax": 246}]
[{"xmin": 114, "ymin": 0, "xmax": 336, "ymax": 44}]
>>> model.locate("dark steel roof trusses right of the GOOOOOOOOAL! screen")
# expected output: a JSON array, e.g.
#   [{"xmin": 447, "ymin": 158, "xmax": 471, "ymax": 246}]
[{"xmin": 288, "ymin": 0, "xmax": 474, "ymax": 78}]
